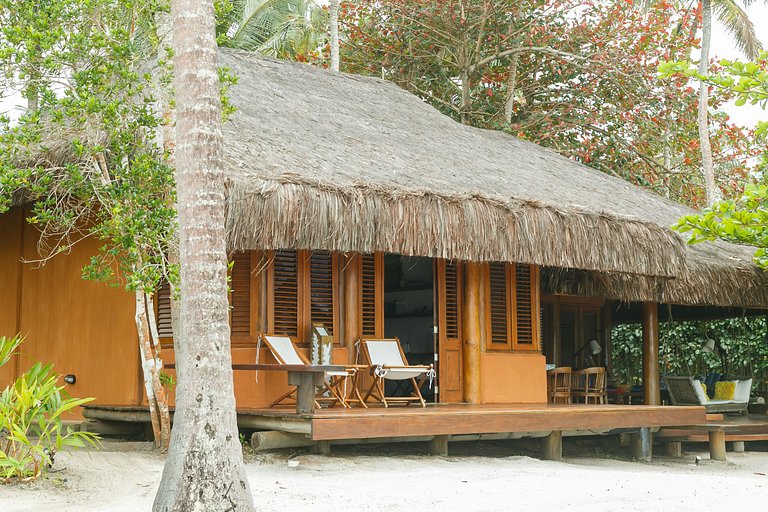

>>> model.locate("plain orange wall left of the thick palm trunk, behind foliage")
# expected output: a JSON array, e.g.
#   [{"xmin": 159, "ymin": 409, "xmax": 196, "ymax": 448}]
[{"xmin": 0, "ymin": 211, "xmax": 139, "ymax": 412}]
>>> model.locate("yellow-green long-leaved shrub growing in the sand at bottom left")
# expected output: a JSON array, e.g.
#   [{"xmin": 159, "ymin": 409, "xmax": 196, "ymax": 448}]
[{"xmin": 0, "ymin": 335, "xmax": 99, "ymax": 482}]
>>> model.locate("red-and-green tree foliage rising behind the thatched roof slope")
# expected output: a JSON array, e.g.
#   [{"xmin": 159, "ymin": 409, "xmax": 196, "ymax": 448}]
[{"xmin": 342, "ymin": 0, "xmax": 756, "ymax": 205}]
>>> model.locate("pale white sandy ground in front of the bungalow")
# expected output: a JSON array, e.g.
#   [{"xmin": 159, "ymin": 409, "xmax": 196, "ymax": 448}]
[{"xmin": 0, "ymin": 440, "xmax": 768, "ymax": 512}]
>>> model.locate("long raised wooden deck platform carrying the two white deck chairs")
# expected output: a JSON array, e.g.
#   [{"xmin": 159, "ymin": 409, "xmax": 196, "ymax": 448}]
[{"xmin": 84, "ymin": 404, "xmax": 706, "ymax": 441}]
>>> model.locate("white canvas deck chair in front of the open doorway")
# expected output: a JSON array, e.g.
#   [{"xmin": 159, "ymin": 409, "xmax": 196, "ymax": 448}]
[{"xmin": 360, "ymin": 338, "xmax": 435, "ymax": 407}]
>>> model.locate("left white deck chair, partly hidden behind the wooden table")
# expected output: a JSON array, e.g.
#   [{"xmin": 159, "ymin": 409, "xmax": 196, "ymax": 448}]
[{"xmin": 259, "ymin": 334, "xmax": 362, "ymax": 408}]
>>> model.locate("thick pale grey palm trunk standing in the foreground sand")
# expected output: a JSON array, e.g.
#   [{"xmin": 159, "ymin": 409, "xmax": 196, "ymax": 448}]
[{"xmin": 153, "ymin": 0, "xmax": 254, "ymax": 512}]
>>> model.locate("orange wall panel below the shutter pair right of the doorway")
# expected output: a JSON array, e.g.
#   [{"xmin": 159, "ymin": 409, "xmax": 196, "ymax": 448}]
[{"xmin": 480, "ymin": 352, "xmax": 547, "ymax": 404}]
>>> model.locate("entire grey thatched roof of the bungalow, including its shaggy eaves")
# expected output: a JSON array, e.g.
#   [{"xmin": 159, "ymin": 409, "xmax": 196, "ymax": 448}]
[{"xmin": 221, "ymin": 51, "xmax": 768, "ymax": 306}]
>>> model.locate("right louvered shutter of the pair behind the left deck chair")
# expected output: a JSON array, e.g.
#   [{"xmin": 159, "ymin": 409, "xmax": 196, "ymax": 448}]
[{"xmin": 307, "ymin": 252, "xmax": 338, "ymax": 339}]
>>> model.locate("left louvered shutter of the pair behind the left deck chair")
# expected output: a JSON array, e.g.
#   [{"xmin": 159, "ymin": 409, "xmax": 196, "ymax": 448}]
[{"xmin": 268, "ymin": 251, "xmax": 299, "ymax": 336}]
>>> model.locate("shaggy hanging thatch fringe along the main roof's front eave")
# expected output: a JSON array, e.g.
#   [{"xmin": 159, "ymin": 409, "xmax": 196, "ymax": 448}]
[{"xmin": 227, "ymin": 176, "xmax": 685, "ymax": 277}]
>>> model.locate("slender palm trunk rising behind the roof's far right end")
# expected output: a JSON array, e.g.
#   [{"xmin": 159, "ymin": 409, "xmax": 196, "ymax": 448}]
[{"xmin": 698, "ymin": 0, "xmax": 722, "ymax": 206}]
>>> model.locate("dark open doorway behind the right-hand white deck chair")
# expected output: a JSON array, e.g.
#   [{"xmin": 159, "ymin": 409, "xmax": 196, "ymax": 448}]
[{"xmin": 384, "ymin": 254, "xmax": 435, "ymax": 402}]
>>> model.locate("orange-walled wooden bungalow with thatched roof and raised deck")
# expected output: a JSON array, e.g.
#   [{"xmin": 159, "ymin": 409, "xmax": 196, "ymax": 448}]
[{"xmin": 0, "ymin": 51, "xmax": 768, "ymax": 456}]
